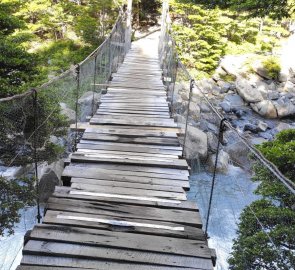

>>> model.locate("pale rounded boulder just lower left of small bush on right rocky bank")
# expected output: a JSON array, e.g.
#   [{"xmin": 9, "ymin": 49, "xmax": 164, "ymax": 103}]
[{"xmin": 236, "ymin": 77, "xmax": 263, "ymax": 103}]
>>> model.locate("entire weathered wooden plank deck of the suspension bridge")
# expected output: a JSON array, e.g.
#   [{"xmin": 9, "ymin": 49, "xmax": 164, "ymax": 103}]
[{"xmin": 18, "ymin": 36, "xmax": 215, "ymax": 270}]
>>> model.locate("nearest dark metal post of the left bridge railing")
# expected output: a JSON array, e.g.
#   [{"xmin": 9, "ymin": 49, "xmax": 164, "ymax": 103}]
[{"xmin": 32, "ymin": 89, "xmax": 41, "ymax": 223}]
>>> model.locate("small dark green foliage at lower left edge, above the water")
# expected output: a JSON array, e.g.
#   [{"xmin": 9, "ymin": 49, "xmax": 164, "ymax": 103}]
[{"xmin": 0, "ymin": 177, "xmax": 36, "ymax": 237}]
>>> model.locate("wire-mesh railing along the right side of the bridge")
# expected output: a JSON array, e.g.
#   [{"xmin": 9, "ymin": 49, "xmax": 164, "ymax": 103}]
[{"xmin": 159, "ymin": 1, "xmax": 295, "ymax": 269}]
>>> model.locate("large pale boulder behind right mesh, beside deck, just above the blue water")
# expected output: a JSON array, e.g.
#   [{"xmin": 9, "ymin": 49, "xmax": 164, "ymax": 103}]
[{"xmin": 185, "ymin": 126, "xmax": 208, "ymax": 160}]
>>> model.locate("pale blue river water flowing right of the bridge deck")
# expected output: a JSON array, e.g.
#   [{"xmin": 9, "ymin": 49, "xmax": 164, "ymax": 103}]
[{"xmin": 188, "ymin": 165, "xmax": 259, "ymax": 270}]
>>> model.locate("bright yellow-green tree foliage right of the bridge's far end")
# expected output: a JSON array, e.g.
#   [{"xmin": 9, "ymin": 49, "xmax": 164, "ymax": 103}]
[{"xmin": 171, "ymin": 1, "xmax": 225, "ymax": 76}]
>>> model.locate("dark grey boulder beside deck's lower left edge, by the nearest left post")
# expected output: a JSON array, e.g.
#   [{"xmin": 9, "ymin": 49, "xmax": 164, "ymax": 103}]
[{"xmin": 39, "ymin": 160, "xmax": 64, "ymax": 202}]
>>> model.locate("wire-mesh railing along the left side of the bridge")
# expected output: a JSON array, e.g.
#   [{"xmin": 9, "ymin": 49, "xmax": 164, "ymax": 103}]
[{"xmin": 0, "ymin": 8, "xmax": 130, "ymax": 269}]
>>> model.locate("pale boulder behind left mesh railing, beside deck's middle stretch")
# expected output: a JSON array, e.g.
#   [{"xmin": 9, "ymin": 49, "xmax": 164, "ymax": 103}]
[{"xmin": 78, "ymin": 91, "xmax": 100, "ymax": 122}]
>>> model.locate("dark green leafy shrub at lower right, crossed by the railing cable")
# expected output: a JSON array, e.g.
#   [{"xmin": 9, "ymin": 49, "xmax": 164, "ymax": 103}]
[{"xmin": 229, "ymin": 130, "xmax": 295, "ymax": 270}]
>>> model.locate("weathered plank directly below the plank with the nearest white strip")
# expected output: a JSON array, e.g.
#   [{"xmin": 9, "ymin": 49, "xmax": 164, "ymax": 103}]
[{"xmin": 29, "ymin": 224, "xmax": 211, "ymax": 259}]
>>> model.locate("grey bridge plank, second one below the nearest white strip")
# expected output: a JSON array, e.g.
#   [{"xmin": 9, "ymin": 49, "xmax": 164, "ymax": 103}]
[{"xmin": 23, "ymin": 240, "xmax": 210, "ymax": 269}]
